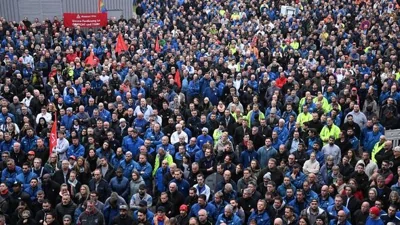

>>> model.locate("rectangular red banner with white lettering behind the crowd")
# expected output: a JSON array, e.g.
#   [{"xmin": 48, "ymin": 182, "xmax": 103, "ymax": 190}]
[{"xmin": 64, "ymin": 13, "xmax": 107, "ymax": 27}]
